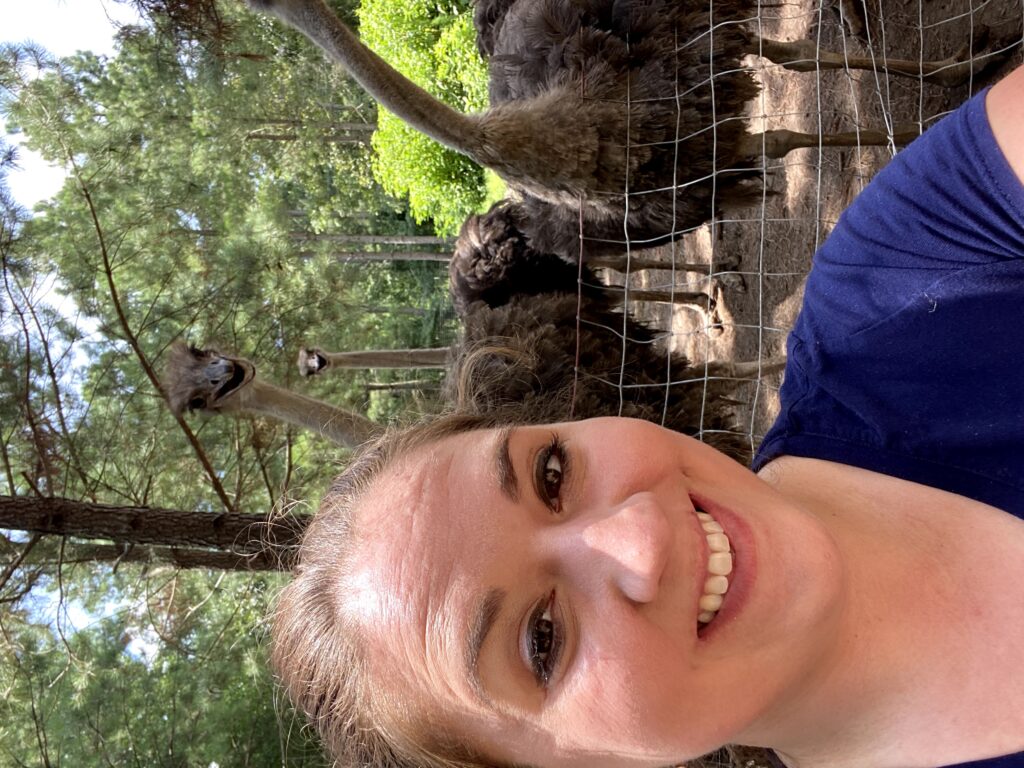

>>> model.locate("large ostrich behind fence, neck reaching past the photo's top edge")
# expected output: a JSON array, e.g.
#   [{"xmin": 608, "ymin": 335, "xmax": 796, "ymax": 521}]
[{"xmin": 243, "ymin": 0, "xmax": 988, "ymax": 259}]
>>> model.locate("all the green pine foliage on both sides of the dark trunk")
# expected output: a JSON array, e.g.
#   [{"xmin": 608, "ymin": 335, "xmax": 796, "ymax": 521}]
[{"xmin": 0, "ymin": 4, "xmax": 451, "ymax": 768}]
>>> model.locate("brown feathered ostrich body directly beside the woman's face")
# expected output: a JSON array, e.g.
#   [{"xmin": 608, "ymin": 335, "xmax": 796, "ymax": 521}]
[{"xmin": 445, "ymin": 293, "xmax": 781, "ymax": 463}]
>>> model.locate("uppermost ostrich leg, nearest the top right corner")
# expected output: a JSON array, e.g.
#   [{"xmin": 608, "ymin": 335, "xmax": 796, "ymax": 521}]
[{"xmin": 751, "ymin": 29, "xmax": 1009, "ymax": 88}]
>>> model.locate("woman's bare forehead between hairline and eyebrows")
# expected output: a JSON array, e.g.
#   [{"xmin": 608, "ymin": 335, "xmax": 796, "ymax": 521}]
[{"xmin": 341, "ymin": 431, "xmax": 505, "ymax": 708}]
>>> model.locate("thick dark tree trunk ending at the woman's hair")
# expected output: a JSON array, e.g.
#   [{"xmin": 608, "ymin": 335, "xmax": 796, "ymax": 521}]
[{"xmin": 0, "ymin": 496, "xmax": 308, "ymax": 559}]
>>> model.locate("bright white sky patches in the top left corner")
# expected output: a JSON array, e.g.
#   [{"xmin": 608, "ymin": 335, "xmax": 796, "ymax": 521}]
[{"xmin": 0, "ymin": 0, "xmax": 144, "ymax": 209}]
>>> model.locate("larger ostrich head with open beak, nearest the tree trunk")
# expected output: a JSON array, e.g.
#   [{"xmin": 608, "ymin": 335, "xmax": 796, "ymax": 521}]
[{"xmin": 164, "ymin": 343, "xmax": 256, "ymax": 414}]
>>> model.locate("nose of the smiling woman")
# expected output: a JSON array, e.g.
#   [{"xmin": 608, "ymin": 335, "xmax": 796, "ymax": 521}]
[{"xmin": 579, "ymin": 493, "xmax": 673, "ymax": 603}]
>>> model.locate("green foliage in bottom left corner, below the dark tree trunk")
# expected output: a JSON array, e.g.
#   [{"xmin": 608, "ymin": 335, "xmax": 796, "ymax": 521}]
[{"xmin": 0, "ymin": 566, "xmax": 326, "ymax": 768}]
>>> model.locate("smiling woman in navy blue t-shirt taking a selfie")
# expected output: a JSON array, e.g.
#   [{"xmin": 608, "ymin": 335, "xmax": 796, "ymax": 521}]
[{"xmin": 272, "ymin": 64, "xmax": 1024, "ymax": 768}]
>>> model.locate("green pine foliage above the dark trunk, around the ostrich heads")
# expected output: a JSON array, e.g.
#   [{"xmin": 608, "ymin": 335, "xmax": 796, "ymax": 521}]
[{"xmin": 4, "ymin": 7, "xmax": 456, "ymax": 511}]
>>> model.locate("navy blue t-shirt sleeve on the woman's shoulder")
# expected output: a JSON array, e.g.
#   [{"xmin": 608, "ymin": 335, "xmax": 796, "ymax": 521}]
[{"xmin": 804, "ymin": 90, "xmax": 1024, "ymax": 336}]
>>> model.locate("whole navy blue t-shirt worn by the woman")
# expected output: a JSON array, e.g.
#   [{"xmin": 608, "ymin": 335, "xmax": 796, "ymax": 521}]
[{"xmin": 753, "ymin": 85, "xmax": 1024, "ymax": 768}]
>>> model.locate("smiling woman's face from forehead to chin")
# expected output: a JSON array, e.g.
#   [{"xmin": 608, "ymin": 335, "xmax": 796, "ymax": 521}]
[{"xmin": 340, "ymin": 419, "xmax": 842, "ymax": 766}]
